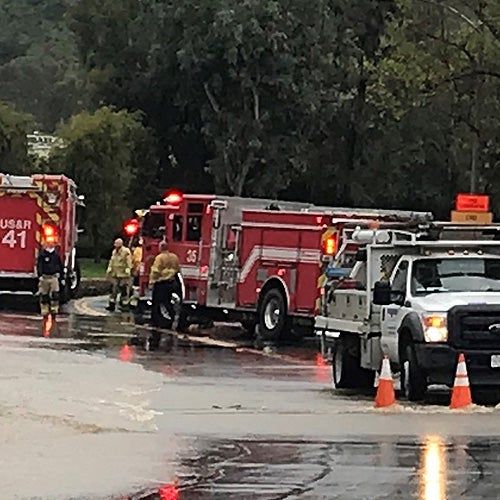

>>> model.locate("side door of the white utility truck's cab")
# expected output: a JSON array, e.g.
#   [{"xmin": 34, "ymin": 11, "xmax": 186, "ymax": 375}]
[{"xmin": 380, "ymin": 260, "xmax": 409, "ymax": 361}]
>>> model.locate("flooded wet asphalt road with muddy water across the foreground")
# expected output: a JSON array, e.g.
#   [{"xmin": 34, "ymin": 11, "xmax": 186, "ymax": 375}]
[{"xmin": 0, "ymin": 299, "xmax": 500, "ymax": 500}]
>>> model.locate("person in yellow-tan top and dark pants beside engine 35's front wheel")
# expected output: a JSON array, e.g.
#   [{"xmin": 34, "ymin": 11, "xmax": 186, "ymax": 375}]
[{"xmin": 149, "ymin": 241, "xmax": 181, "ymax": 327}]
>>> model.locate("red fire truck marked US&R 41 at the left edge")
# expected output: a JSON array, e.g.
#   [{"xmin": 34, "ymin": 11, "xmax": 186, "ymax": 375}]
[{"xmin": 0, "ymin": 173, "xmax": 83, "ymax": 302}]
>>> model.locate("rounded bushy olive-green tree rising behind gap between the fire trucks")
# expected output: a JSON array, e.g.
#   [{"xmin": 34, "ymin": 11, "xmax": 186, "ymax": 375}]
[{"xmin": 51, "ymin": 107, "xmax": 154, "ymax": 258}]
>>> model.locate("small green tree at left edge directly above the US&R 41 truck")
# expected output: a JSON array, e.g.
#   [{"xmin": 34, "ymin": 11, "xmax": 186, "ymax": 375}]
[{"xmin": 0, "ymin": 101, "xmax": 33, "ymax": 175}]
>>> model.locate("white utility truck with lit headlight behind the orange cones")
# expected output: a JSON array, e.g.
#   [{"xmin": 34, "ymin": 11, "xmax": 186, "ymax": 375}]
[{"xmin": 315, "ymin": 222, "xmax": 500, "ymax": 401}]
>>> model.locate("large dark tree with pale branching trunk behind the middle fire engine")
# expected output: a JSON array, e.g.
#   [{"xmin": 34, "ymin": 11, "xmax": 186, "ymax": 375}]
[{"xmin": 67, "ymin": 0, "xmax": 390, "ymax": 199}]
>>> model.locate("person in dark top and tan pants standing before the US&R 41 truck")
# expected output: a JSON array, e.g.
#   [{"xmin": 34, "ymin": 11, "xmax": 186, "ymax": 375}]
[{"xmin": 36, "ymin": 243, "xmax": 64, "ymax": 318}]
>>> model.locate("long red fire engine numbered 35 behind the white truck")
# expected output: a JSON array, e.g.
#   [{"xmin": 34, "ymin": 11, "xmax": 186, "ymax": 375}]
[{"xmin": 139, "ymin": 192, "xmax": 434, "ymax": 340}]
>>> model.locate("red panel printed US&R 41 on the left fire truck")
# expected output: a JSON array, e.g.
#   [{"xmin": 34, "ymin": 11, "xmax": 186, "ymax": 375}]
[{"xmin": 0, "ymin": 193, "xmax": 39, "ymax": 274}]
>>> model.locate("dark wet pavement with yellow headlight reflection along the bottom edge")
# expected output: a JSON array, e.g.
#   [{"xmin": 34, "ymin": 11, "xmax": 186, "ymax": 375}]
[{"xmin": 123, "ymin": 435, "xmax": 500, "ymax": 500}]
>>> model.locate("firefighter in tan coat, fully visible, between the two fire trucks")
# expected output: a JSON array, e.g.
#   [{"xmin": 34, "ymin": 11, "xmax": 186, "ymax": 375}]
[{"xmin": 106, "ymin": 238, "xmax": 132, "ymax": 311}]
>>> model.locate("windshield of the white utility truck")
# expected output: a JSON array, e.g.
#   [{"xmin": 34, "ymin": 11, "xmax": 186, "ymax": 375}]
[{"xmin": 411, "ymin": 257, "xmax": 500, "ymax": 295}]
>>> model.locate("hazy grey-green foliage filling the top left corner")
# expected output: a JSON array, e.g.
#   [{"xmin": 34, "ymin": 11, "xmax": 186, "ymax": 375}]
[{"xmin": 0, "ymin": 0, "xmax": 86, "ymax": 130}]
